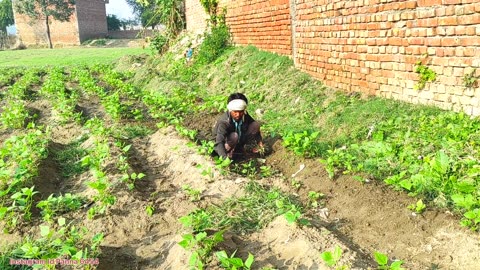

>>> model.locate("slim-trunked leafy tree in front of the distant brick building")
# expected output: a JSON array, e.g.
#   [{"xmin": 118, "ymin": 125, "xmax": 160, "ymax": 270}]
[{"xmin": 15, "ymin": 0, "xmax": 75, "ymax": 49}]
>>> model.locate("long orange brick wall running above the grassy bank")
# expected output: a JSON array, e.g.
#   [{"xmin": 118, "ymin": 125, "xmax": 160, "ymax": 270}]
[{"xmin": 187, "ymin": 0, "xmax": 480, "ymax": 115}]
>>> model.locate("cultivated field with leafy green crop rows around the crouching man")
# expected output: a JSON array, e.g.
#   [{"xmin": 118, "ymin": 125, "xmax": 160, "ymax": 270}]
[{"xmin": 0, "ymin": 46, "xmax": 480, "ymax": 269}]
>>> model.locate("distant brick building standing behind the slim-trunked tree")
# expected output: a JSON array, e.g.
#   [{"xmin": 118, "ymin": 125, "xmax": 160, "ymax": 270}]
[{"xmin": 14, "ymin": 0, "xmax": 107, "ymax": 47}]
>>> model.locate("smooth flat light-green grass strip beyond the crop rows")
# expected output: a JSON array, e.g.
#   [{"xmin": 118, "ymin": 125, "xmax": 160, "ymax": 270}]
[{"xmin": 0, "ymin": 48, "xmax": 147, "ymax": 67}]
